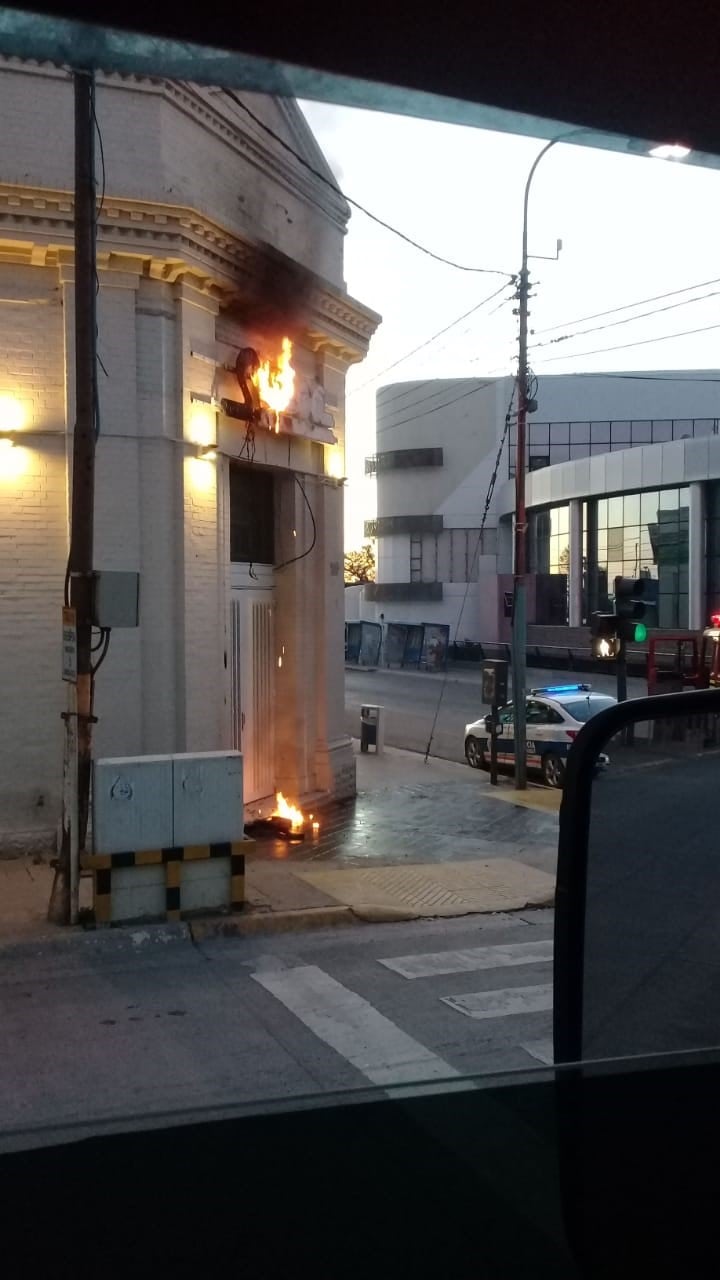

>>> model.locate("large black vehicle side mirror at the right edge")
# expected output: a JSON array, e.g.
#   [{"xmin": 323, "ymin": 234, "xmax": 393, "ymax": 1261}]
[{"xmin": 555, "ymin": 690, "xmax": 720, "ymax": 1062}]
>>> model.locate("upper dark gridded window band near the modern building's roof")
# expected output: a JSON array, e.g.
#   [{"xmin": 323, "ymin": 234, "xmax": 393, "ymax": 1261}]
[{"xmin": 509, "ymin": 417, "xmax": 720, "ymax": 476}]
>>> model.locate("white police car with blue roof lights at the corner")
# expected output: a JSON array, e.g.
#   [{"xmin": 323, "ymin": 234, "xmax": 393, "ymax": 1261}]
[{"xmin": 465, "ymin": 685, "xmax": 615, "ymax": 787}]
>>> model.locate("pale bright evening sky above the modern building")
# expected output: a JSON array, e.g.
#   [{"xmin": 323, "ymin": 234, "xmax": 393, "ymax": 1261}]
[{"xmin": 295, "ymin": 102, "xmax": 720, "ymax": 548}]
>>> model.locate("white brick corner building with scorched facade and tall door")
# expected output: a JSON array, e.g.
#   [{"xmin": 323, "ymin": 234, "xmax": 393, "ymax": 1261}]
[{"xmin": 0, "ymin": 60, "xmax": 379, "ymax": 851}]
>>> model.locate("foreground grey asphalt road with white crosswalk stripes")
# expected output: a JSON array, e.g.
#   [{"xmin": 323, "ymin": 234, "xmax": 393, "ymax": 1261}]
[{"xmin": 0, "ymin": 910, "xmax": 552, "ymax": 1149}]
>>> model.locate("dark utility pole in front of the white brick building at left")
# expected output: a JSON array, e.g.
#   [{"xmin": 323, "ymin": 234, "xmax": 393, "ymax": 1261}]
[{"xmin": 47, "ymin": 70, "xmax": 97, "ymax": 924}]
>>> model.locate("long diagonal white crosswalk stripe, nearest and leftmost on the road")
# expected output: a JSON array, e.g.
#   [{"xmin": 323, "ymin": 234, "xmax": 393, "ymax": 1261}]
[{"xmin": 252, "ymin": 965, "xmax": 460, "ymax": 1085}]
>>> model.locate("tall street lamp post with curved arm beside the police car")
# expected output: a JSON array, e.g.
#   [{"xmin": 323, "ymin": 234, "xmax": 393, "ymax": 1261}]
[{"xmin": 512, "ymin": 129, "xmax": 571, "ymax": 791}]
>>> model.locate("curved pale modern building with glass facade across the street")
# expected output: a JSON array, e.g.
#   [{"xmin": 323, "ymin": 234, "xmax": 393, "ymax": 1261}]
[{"xmin": 364, "ymin": 370, "xmax": 720, "ymax": 644}]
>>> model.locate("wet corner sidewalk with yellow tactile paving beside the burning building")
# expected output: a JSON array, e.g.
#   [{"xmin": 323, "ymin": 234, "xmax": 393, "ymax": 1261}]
[{"xmin": 0, "ymin": 742, "xmax": 560, "ymax": 946}]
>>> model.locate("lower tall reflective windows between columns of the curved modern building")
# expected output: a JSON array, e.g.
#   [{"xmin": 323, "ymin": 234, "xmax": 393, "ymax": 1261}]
[{"xmin": 529, "ymin": 485, "xmax": 691, "ymax": 630}]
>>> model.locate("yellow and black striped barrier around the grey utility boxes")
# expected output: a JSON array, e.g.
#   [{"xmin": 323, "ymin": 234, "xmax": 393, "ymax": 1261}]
[{"xmin": 81, "ymin": 840, "xmax": 249, "ymax": 924}]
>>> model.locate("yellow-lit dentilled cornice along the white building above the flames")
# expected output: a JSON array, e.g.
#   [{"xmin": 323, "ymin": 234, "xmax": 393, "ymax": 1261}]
[{"xmin": 0, "ymin": 183, "xmax": 380, "ymax": 364}]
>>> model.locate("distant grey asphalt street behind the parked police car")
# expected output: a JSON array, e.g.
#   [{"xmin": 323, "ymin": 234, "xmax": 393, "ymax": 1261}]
[{"xmin": 345, "ymin": 668, "xmax": 647, "ymax": 760}]
